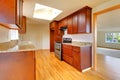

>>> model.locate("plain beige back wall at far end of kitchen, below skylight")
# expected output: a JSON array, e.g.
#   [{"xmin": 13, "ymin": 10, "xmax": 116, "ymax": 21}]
[{"xmin": 20, "ymin": 23, "xmax": 50, "ymax": 49}]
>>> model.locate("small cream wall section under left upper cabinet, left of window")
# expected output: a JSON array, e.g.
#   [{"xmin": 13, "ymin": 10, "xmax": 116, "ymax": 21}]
[{"xmin": 0, "ymin": 26, "xmax": 10, "ymax": 43}]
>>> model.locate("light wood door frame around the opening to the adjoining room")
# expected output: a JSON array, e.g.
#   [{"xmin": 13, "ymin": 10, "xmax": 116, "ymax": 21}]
[{"xmin": 93, "ymin": 4, "xmax": 120, "ymax": 70}]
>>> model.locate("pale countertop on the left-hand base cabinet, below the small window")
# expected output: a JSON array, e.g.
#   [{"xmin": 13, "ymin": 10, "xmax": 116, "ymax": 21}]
[{"xmin": 0, "ymin": 43, "xmax": 35, "ymax": 53}]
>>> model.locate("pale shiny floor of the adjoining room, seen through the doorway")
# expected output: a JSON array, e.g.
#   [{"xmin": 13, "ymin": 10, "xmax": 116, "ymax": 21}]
[{"xmin": 97, "ymin": 53, "xmax": 120, "ymax": 80}]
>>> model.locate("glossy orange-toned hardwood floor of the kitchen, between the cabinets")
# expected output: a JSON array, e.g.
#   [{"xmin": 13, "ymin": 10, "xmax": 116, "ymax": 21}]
[{"xmin": 36, "ymin": 50, "xmax": 106, "ymax": 80}]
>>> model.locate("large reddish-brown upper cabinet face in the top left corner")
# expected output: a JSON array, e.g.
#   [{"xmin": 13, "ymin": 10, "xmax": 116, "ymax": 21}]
[{"xmin": 0, "ymin": 0, "xmax": 16, "ymax": 24}]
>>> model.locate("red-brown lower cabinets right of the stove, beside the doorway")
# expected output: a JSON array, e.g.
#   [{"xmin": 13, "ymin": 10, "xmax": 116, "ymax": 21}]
[{"xmin": 63, "ymin": 44, "xmax": 92, "ymax": 71}]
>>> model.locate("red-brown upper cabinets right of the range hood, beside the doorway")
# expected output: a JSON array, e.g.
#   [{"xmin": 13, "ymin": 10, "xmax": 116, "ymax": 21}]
[{"xmin": 67, "ymin": 6, "xmax": 91, "ymax": 34}]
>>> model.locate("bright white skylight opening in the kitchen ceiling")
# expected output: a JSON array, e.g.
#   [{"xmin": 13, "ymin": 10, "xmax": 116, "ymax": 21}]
[{"xmin": 33, "ymin": 3, "xmax": 62, "ymax": 20}]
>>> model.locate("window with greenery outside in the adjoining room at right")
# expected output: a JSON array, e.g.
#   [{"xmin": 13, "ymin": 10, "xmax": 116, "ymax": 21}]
[{"xmin": 105, "ymin": 33, "xmax": 120, "ymax": 43}]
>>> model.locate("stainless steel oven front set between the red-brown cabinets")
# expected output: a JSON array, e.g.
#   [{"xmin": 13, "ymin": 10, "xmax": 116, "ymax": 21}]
[{"xmin": 54, "ymin": 42, "xmax": 62, "ymax": 60}]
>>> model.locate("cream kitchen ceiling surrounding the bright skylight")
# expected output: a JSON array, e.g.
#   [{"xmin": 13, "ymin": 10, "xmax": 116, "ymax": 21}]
[{"xmin": 23, "ymin": 0, "xmax": 109, "ymax": 24}]
